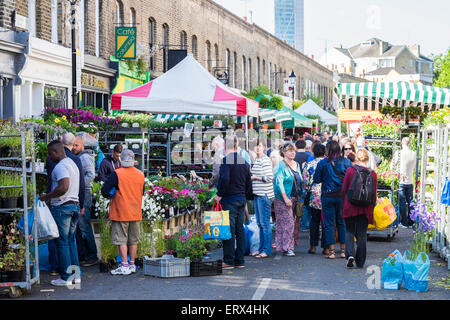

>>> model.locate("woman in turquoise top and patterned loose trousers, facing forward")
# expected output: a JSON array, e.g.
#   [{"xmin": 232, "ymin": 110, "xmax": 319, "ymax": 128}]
[{"xmin": 274, "ymin": 142, "xmax": 302, "ymax": 257}]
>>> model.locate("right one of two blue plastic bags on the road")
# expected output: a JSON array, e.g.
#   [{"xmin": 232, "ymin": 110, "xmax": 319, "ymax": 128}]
[{"xmin": 403, "ymin": 250, "xmax": 430, "ymax": 292}]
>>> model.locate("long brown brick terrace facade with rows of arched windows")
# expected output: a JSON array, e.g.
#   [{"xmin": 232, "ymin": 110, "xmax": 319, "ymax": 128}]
[{"xmin": 0, "ymin": 0, "xmax": 334, "ymax": 115}]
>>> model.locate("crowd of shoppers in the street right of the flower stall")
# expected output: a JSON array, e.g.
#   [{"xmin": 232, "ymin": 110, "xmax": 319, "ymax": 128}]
[{"xmin": 210, "ymin": 132, "xmax": 390, "ymax": 269}]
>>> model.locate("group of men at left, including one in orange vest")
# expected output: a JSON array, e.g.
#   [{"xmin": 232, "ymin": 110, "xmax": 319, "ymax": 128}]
[{"xmin": 39, "ymin": 129, "xmax": 148, "ymax": 286}]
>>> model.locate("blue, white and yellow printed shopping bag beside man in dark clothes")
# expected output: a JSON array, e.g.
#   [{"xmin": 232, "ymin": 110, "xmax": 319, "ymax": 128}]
[{"xmin": 203, "ymin": 203, "xmax": 231, "ymax": 240}]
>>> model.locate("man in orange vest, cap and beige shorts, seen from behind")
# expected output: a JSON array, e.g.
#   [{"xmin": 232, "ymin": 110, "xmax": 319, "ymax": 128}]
[{"xmin": 102, "ymin": 149, "xmax": 145, "ymax": 275}]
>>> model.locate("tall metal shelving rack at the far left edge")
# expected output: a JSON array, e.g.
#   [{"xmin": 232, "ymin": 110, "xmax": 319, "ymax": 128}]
[{"xmin": 0, "ymin": 127, "xmax": 40, "ymax": 298}]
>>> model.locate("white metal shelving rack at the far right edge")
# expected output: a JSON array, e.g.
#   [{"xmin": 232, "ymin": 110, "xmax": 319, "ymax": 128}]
[{"xmin": 420, "ymin": 124, "xmax": 450, "ymax": 270}]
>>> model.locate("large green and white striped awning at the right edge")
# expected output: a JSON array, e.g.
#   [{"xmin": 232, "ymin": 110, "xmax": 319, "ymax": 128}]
[{"xmin": 336, "ymin": 82, "xmax": 450, "ymax": 106}]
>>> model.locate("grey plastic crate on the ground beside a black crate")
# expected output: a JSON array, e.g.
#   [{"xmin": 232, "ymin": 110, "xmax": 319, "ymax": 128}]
[{"xmin": 144, "ymin": 255, "xmax": 190, "ymax": 278}]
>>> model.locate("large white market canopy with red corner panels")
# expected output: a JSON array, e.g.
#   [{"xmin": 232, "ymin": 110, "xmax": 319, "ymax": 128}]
[{"xmin": 111, "ymin": 54, "xmax": 259, "ymax": 117}]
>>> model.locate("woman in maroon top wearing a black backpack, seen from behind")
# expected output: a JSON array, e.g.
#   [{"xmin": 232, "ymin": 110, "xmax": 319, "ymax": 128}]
[{"xmin": 342, "ymin": 149, "xmax": 377, "ymax": 268}]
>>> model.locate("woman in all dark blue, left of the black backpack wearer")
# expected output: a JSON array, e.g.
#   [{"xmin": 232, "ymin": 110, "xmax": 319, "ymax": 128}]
[{"xmin": 314, "ymin": 141, "xmax": 352, "ymax": 259}]
